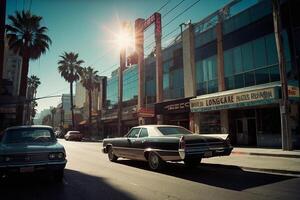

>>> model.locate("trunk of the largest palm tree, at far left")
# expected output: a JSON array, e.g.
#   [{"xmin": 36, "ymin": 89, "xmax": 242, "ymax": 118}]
[{"xmin": 16, "ymin": 50, "xmax": 29, "ymax": 125}]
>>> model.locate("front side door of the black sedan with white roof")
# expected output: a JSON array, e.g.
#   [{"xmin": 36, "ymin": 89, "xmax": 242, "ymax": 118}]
[{"xmin": 123, "ymin": 128, "xmax": 141, "ymax": 159}]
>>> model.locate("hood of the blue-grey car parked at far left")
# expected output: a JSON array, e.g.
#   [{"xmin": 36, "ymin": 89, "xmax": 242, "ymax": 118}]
[{"xmin": 0, "ymin": 142, "xmax": 65, "ymax": 154}]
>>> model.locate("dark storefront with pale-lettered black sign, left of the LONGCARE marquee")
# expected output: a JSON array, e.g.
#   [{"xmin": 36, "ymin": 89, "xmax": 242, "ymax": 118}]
[{"xmin": 155, "ymin": 98, "xmax": 191, "ymax": 129}]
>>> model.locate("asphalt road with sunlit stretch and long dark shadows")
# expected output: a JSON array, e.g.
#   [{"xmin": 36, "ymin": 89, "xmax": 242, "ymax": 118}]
[{"xmin": 0, "ymin": 140, "xmax": 300, "ymax": 200}]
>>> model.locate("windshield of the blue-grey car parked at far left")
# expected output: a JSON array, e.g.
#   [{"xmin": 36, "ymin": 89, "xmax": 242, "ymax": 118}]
[{"xmin": 3, "ymin": 128, "xmax": 55, "ymax": 144}]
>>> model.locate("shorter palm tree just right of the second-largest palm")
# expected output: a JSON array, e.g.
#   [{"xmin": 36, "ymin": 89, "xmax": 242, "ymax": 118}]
[{"xmin": 80, "ymin": 67, "xmax": 98, "ymax": 125}]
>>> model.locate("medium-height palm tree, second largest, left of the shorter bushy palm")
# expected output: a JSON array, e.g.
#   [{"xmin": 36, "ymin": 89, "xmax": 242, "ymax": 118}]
[{"xmin": 58, "ymin": 52, "xmax": 84, "ymax": 129}]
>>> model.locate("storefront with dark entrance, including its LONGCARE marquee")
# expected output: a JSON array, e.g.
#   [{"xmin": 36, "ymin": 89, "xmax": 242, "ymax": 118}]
[{"xmin": 190, "ymin": 83, "xmax": 300, "ymax": 147}]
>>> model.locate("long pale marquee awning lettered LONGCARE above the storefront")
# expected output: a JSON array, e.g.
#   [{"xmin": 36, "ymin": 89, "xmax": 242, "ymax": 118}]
[{"xmin": 190, "ymin": 82, "xmax": 280, "ymax": 112}]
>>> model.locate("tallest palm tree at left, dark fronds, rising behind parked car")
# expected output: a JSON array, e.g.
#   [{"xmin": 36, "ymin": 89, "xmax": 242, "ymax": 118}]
[{"xmin": 6, "ymin": 11, "xmax": 51, "ymax": 124}]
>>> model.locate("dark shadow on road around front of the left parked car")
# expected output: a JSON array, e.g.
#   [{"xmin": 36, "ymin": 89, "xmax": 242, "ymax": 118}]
[{"xmin": 0, "ymin": 169, "xmax": 134, "ymax": 200}]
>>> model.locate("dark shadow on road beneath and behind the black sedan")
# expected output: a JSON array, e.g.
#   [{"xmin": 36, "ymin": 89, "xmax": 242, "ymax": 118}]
[{"xmin": 117, "ymin": 160, "xmax": 296, "ymax": 191}]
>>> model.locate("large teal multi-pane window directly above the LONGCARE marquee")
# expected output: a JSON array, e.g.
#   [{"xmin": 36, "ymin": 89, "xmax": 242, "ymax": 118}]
[{"xmin": 224, "ymin": 31, "xmax": 292, "ymax": 90}]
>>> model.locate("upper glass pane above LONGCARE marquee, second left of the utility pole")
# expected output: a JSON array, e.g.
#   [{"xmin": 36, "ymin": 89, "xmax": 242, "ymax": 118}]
[{"xmin": 253, "ymin": 38, "xmax": 267, "ymax": 68}]
